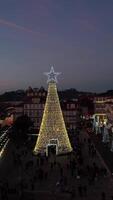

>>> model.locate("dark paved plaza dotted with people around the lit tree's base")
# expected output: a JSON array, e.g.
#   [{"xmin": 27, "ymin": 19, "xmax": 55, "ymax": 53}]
[{"xmin": 0, "ymin": 130, "xmax": 113, "ymax": 200}]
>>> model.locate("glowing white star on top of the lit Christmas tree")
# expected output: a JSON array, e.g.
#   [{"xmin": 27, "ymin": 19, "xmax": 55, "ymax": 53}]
[{"xmin": 44, "ymin": 66, "xmax": 61, "ymax": 83}]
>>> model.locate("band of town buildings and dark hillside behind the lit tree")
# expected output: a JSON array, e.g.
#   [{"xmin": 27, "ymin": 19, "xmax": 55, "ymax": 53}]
[{"xmin": 0, "ymin": 87, "xmax": 113, "ymax": 129}]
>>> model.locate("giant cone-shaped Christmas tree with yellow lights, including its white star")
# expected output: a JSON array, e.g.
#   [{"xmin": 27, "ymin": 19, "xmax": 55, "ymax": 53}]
[{"xmin": 34, "ymin": 67, "xmax": 72, "ymax": 155}]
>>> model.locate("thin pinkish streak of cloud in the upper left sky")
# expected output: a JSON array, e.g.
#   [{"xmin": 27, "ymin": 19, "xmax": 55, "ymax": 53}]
[{"xmin": 0, "ymin": 19, "xmax": 39, "ymax": 34}]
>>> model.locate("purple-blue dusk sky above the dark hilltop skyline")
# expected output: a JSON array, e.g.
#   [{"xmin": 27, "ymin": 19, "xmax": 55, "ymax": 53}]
[{"xmin": 0, "ymin": 0, "xmax": 113, "ymax": 93}]
